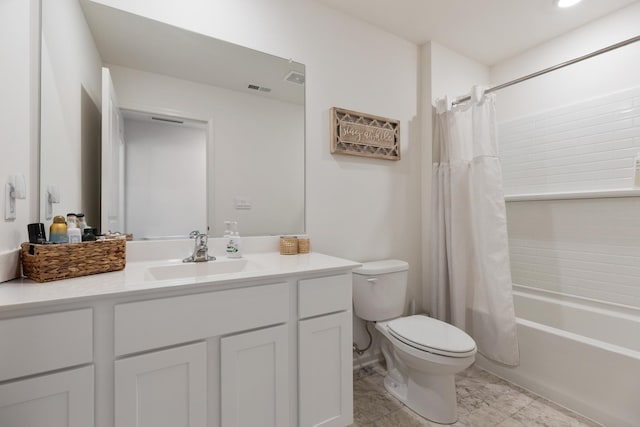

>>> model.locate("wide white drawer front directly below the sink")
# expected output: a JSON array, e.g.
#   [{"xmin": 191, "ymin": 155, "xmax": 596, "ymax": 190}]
[{"xmin": 115, "ymin": 283, "xmax": 289, "ymax": 356}]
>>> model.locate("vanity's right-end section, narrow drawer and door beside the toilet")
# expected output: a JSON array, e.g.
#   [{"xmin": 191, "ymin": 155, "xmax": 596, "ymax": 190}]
[{"xmin": 298, "ymin": 274, "xmax": 353, "ymax": 427}]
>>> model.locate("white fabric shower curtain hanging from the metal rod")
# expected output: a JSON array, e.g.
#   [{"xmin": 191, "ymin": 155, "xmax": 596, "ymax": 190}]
[{"xmin": 430, "ymin": 87, "xmax": 519, "ymax": 365}]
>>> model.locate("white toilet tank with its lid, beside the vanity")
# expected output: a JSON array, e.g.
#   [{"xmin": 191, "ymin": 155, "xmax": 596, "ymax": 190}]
[{"xmin": 353, "ymin": 259, "xmax": 409, "ymax": 321}]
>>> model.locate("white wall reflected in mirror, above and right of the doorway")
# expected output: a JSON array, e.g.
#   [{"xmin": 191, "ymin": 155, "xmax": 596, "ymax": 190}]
[{"xmin": 110, "ymin": 66, "xmax": 304, "ymax": 235}]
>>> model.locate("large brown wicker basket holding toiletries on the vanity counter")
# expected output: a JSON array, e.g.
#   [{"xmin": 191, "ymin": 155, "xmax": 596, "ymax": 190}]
[{"xmin": 20, "ymin": 239, "xmax": 127, "ymax": 283}]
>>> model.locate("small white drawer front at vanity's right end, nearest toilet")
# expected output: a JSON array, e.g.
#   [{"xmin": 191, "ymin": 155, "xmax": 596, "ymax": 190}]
[{"xmin": 298, "ymin": 273, "xmax": 351, "ymax": 318}]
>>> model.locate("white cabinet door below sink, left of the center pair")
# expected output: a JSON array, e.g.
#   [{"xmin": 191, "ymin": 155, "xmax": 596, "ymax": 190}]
[{"xmin": 115, "ymin": 342, "xmax": 207, "ymax": 427}]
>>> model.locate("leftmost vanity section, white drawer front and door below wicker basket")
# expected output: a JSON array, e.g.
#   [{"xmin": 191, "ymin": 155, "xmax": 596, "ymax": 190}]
[{"xmin": 0, "ymin": 309, "xmax": 94, "ymax": 427}]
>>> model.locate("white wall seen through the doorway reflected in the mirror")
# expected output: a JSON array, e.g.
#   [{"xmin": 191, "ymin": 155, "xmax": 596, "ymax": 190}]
[{"xmin": 124, "ymin": 118, "xmax": 207, "ymax": 239}]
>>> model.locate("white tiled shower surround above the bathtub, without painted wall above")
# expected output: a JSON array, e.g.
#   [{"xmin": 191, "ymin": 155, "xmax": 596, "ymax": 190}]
[{"xmin": 498, "ymin": 88, "xmax": 640, "ymax": 307}]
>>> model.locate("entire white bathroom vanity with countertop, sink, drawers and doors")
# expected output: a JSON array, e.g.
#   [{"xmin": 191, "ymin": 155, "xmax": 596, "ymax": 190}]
[{"xmin": 0, "ymin": 239, "xmax": 359, "ymax": 427}]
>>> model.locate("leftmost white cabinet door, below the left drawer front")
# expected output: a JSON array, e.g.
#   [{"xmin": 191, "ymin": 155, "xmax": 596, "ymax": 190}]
[{"xmin": 0, "ymin": 366, "xmax": 94, "ymax": 427}]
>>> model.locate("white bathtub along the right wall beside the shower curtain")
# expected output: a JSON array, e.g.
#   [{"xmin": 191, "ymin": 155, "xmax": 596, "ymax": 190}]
[{"xmin": 476, "ymin": 285, "xmax": 640, "ymax": 427}]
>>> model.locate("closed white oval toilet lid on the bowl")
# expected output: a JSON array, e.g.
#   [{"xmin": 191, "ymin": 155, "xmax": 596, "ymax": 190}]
[{"xmin": 388, "ymin": 315, "xmax": 476, "ymax": 357}]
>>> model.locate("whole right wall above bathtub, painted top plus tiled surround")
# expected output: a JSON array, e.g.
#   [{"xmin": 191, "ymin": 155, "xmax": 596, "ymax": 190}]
[{"xmin": 491, "ymin": 3, "xmax": 640, "ymax": 307}]
